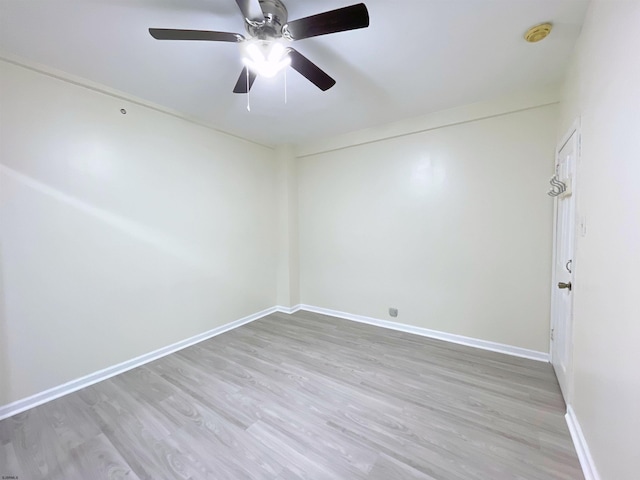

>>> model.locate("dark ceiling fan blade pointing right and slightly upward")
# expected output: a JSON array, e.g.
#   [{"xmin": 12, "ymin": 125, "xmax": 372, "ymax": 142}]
[{"xmin": 282, "ymin": 3, "xmax": 369, "ymax": 40}]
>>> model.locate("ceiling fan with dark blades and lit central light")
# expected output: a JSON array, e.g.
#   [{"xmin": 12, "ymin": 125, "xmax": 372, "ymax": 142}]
[{"xmin": 149, "ymin": 0, "xmax": 369, "ymax": 93}]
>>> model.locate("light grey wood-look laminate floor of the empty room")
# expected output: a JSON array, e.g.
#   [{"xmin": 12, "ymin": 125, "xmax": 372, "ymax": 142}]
[{"xmin": 0, "ymin": 312, "xmax": 584, "ymax": 480}]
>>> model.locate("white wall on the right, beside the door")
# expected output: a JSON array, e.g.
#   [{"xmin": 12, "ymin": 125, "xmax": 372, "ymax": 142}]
[{"xmin": 559, "ymin": 0, "xmax": 640, "ymax": 480}]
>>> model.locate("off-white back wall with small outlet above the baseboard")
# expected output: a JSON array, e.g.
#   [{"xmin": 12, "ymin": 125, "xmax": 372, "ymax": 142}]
[{"xmin": 298, "ymin": 105, "xmax": 557, "ymax": 352}]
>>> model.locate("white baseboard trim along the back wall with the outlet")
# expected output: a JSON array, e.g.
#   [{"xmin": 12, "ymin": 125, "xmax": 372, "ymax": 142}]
[{"xmin": 297, "ymin": 304, "xmax": 549, "ymax": 362}]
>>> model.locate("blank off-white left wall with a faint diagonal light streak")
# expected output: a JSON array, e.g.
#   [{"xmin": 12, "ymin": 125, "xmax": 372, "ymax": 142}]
[{"xmin": 0, "ymin": 61, "xmax": 277, "ymax": 405}]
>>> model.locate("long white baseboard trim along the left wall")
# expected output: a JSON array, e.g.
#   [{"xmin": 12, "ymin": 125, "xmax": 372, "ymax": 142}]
[{"xmin": 0, "ymin": 307, "xmax": 278, "ymax": 420}]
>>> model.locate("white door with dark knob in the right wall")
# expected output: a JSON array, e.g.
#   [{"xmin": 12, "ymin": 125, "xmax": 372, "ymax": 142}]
[{"xmin": 551, "ymin": 131, "xmax": 579, "ymax": 404}]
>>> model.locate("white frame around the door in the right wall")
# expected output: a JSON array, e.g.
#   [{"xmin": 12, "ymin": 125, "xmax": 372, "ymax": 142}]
[{"xmin": 549, "ymin": 117, "xmax": 582, "ymax": 406}]
